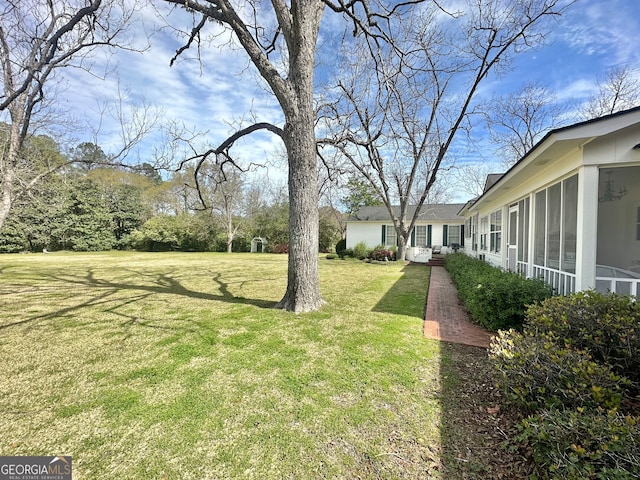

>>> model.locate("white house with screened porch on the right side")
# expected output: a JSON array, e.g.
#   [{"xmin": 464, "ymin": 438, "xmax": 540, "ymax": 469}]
[{"xmin": 458, "ymin": 107, "xmax": 640, "ymax": 295}]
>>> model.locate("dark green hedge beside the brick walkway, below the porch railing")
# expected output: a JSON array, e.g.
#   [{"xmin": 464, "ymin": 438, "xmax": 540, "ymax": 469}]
[{"xmin": 445, "ymin": 253, "xmax": 552, "ymax": 331}]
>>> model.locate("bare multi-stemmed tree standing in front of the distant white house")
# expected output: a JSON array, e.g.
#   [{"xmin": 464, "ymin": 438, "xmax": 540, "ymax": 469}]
[{"xmin": 322, "ymin": 0, "xmax": 571, "ymax": 259}]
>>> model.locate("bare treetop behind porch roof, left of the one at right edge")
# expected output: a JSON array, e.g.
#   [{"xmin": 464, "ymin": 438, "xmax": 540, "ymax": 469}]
[{"xmin": 483, "ymin": 82, "xmax": 568, "ymax": 170}]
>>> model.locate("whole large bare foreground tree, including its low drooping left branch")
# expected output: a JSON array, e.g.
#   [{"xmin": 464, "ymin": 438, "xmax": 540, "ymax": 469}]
[{"xmin": 159, "ymin": 0, "xmax": 436, "ymax": 312}]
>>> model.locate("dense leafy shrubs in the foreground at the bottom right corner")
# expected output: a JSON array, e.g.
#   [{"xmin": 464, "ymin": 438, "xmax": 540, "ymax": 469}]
[{"xmin": 489, "ymin": 292, "xmax": 640, "ymax": 479}]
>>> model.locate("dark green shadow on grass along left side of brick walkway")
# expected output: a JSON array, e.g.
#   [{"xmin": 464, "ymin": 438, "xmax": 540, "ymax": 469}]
[{"xmin": 373, "ymin": 265, "xmax": 431, "ymax": 319}]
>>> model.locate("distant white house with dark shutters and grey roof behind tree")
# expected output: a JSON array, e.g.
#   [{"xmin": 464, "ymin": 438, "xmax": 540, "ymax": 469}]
[{"xmin": 347, "ymin": 204, "xmax": 465, "ymax": 262}]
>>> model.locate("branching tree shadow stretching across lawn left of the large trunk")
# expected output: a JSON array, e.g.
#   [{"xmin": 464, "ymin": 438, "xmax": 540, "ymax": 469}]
[{"xmin": 0, "ymin": 269, "xmax": 276, "ymax": 331}]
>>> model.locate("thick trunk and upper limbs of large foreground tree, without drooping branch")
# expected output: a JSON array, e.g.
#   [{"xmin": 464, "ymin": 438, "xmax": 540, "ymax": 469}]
[{"xmin": 166, "ymin": 0, "xmax": 328, "ymax": 312}]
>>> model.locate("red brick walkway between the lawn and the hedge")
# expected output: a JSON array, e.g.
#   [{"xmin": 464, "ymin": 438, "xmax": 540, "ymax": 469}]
[{"xmin": 423, "ymin": 267, "xmax": 492, "ymax": 348}]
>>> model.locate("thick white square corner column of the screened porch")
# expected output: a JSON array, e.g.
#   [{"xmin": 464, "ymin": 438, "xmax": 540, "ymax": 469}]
[{"xmin": 576, "ymin": 165, "xmax": 600, "ymax": 291}]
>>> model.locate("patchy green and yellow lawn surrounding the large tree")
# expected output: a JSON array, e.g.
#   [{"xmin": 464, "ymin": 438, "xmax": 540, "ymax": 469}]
[{"xmin": 0, "ymin": 253, "xmax": 496, "ymax": 479}]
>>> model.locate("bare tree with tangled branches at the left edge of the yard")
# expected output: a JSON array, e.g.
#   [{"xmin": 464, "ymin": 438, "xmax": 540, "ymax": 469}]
[{"xmin": 0, "ymin": 0, "xmax": 148, "ymax": 232}]
